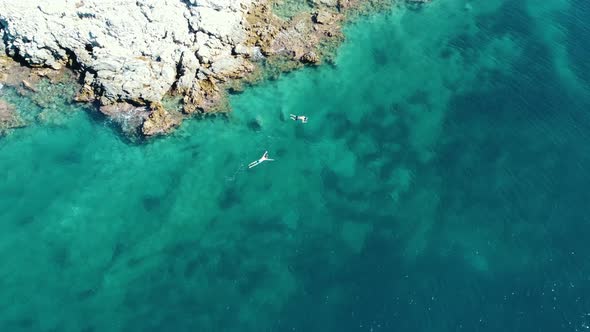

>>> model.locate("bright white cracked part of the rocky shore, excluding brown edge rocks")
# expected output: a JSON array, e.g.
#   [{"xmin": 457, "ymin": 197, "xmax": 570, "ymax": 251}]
[{"xmin": 0, "ymin": 0, "xmax": 255, "ymax": 104}]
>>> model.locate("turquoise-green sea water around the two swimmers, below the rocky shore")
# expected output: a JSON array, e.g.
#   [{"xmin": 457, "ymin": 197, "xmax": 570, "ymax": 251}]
[{"xmin": 0, "ymin": 0, "xmax": 590, "ymax": 332}]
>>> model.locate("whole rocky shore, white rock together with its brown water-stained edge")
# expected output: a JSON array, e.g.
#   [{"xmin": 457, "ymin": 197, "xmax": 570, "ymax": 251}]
[{"xmin": 0, "ymin": 0, "xmax": 426, "ymax": 136}]
